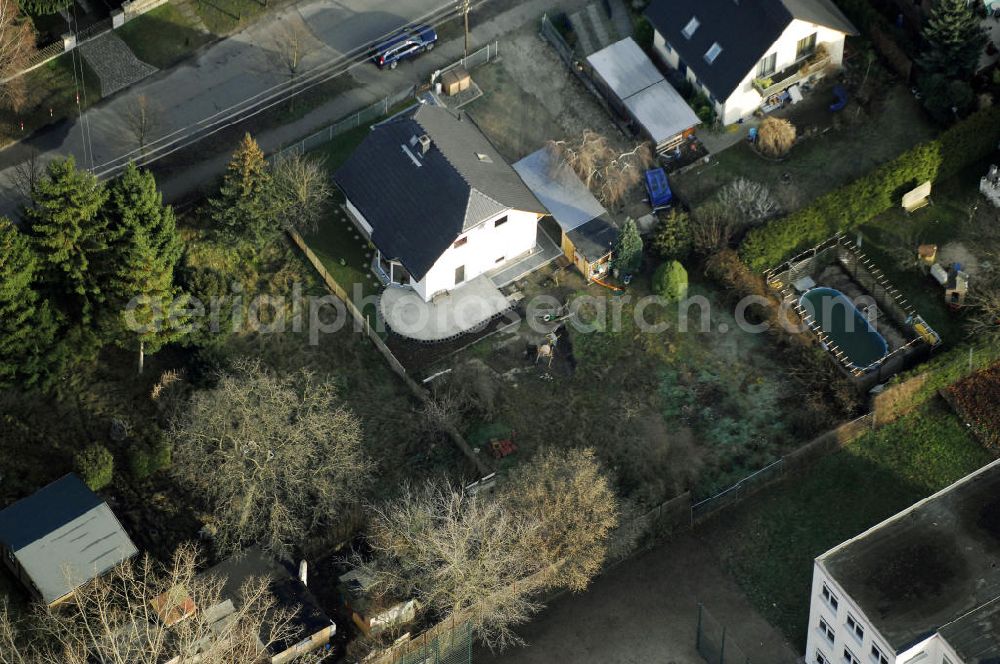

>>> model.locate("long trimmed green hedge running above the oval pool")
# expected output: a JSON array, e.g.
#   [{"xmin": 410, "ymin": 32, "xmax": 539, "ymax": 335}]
[{"xmin": 740, "ymin": 106, "xmax": 1000, "ymax": 271}]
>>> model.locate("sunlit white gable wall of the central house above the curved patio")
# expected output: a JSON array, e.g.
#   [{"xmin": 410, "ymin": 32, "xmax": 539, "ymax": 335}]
[{"xmin": 413, "ymin": 210, "xmax": 538, "ymax": 301}]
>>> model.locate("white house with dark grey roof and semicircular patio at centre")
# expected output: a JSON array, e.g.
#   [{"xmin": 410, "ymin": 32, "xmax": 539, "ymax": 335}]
[{"xmin": 334, "ymin": 105, "xmax": 546, "ymax": 302}]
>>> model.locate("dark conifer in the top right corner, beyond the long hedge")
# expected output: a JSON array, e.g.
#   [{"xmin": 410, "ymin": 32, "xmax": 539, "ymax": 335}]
[{"xmin": 917, "ymin": 0, "xmax": 987, "ymax": 80}]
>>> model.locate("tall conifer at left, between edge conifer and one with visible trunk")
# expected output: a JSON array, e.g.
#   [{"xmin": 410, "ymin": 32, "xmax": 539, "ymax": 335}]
[{"xmin": 26, "ymin": 157, "xmax": 107, "ymax": 324}]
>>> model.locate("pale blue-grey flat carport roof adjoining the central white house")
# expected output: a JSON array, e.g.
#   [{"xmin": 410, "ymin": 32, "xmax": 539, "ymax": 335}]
[{"xmin": 514, "ymin": 148, "xmax": 606, "ymax": 233}]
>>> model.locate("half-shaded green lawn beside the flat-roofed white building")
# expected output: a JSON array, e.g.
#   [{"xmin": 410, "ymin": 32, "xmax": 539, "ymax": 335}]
[{"xmin": 707, "ymin": 399, "xmax": 991, "ymax": 651}]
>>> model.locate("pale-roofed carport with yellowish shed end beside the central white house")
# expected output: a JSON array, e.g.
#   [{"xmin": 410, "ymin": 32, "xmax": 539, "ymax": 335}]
[{"xmin": 514, "ymin": 148, "xmax": 618, "ymax": 281}]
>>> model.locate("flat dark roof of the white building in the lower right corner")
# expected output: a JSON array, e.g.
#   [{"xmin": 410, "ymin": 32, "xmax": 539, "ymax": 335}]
[{"xmin": 817, "ymin": 462, "xmax": 1000, "ymax": 653}]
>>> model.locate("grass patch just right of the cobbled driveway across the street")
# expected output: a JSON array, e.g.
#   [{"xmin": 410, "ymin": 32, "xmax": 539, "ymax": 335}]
[{"xmin": 118, "ymin": 4, "xmax": 212, "ymax": 69}]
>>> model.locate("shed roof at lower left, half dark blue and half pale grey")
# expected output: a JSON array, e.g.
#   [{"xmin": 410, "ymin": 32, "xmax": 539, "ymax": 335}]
[{"xmin": 0, "ymin": 474, "xmax": 138, "ymax": 604}]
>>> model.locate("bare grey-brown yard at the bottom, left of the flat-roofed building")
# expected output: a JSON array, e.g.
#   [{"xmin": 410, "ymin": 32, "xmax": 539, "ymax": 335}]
[{"xmin": 474, "ymin": 535, "xmax": 797, "ymax": 664}]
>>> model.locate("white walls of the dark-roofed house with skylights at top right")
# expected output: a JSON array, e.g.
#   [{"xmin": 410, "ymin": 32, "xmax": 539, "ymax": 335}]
[{"xmin": 653, "ymin": 19, "xmax": 845, "ymax": 125}]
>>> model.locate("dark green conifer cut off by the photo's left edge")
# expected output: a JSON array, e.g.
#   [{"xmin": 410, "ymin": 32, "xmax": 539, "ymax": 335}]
[{"xmin": 0, "ymin": 217, "xmax": 58, "ymax": 387}]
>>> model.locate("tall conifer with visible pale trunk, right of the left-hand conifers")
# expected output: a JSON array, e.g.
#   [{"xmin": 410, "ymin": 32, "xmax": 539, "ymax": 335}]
[{"xmin": 101, "ymin": 164, "xmax": 189, "ymax": 373}]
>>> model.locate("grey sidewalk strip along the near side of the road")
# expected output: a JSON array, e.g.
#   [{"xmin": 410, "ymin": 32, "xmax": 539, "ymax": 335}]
[{"xmin": 160, "ymin": 0, "xmax": 588, "ymax": 201}]
